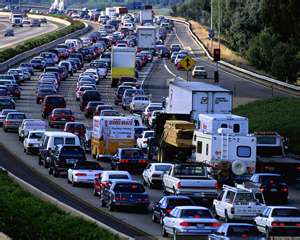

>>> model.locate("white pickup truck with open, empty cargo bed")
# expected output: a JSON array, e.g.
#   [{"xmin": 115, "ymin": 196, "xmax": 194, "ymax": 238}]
[{"xmin": 163, "ymin": 163, "xmax": 218, "ymax": 201}]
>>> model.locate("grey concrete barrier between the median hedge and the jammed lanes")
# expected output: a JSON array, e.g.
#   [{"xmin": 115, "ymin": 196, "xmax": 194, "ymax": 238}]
[{"xmin": 0, "ymin": 23, "xmax": 91, "ymax": 72}]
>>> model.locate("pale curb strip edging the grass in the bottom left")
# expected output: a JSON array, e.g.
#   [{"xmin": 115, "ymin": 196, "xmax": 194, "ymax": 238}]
[{"xmin": 6, "ymin": 170, "xmax": 134, "ymax": 240}]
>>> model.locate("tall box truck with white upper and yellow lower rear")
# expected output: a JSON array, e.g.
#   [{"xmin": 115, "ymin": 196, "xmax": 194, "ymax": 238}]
[{"xmin": 111, "ymin": 47, "xmax": 136, "ymax": 87}]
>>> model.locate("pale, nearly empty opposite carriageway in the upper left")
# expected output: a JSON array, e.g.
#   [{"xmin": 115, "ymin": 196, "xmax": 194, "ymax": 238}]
[{"xmin": 0, "ymin": 17, "xmax": 64, "ymax": 49}]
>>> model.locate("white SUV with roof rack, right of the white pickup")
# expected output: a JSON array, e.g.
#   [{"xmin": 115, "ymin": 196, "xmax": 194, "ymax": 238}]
[{"xmin": 212, "ymin": 185, "xmax": 266, "ymax": 222}]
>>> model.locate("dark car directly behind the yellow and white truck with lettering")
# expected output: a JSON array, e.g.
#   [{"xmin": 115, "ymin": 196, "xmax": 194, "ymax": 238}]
[{"xmin": 111, "ymin": 148, "xmax": 149, "ymax": 171}]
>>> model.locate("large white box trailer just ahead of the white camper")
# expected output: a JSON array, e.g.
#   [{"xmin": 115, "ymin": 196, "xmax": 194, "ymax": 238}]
[{"xmin": 167, "ymin": 79, "xmax": 232, "ymax": 121}]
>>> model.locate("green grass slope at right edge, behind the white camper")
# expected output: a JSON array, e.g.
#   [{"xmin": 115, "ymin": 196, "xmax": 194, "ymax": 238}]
[{"xmin": 234, "ymin": 98, "xmax": 300, "ymax": 155}]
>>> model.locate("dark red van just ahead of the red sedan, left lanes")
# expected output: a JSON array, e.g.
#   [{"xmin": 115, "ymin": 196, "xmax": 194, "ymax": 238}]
[{"xmin": 42, "ymin": 95, "xmax": 66, "ymax": 118}]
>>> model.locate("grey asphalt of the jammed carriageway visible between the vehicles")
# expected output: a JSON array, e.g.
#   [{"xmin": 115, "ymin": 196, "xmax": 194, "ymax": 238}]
[{"xmin": 0, "ymin": 19, "xmax": 300, "ymax": 240}]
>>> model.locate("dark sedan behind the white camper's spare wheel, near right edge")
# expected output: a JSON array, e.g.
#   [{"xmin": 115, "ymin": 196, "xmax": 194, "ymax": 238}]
[{"xmin": 250, "ymin": 173, "xmax": 289, "ymax": 203}]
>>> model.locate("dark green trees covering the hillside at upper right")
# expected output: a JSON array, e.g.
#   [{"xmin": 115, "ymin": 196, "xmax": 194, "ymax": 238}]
[{"xmin": 172, "ymin": 0, "xmax": 300, "ymax": 83}]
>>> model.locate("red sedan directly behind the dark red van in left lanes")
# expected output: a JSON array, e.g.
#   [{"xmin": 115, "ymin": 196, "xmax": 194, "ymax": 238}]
[{"xmin": 48, "ymin": 108, "xmax": 75, "ymax": 127}]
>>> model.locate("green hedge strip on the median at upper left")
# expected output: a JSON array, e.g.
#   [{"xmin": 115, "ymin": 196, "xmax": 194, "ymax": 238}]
[{"xmin": 0, "ymin": 19, "xmax": 85, "ymax": 62}]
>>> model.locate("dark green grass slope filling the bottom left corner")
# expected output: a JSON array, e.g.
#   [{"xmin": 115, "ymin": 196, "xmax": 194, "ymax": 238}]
[{"xmin": 0, "ymin": 172, "xmax": 120, "ymax": 240}]
